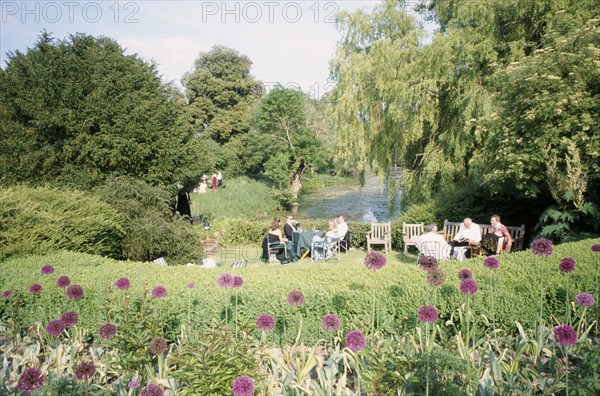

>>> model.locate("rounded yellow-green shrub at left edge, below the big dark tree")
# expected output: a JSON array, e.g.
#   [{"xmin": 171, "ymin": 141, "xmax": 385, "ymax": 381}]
[{"xmin": 0, "ymin": 186, "xmax": 125, "ymax": 258}]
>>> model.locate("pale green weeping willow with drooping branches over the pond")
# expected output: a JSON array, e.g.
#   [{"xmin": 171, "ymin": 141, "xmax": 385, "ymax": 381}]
[{"xmin": 330, "ymin": 1, "xmax": 495, "ymax": 202}]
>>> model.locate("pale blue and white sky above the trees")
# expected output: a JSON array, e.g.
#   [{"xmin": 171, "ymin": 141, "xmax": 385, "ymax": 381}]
[{"xmin": 0, "ymin": 0, "xmax": 432, "ymax": 98}]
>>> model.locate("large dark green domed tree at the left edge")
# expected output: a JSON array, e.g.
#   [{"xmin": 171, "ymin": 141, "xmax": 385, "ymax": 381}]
[{"xmin": 0, "ymin": 32, "xmax": 206, "ymax": 188}]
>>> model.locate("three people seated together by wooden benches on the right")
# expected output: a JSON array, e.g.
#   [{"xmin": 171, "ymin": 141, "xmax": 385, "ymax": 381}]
[{"xmin": 419, "ymin": 214, "xmax": 512, "ymax": 260}]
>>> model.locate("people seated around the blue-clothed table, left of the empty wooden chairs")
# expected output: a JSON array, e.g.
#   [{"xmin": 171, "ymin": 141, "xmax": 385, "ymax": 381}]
[{"xmin": 262, "ymin": 215, "xmax": 350, "ymax": 264}]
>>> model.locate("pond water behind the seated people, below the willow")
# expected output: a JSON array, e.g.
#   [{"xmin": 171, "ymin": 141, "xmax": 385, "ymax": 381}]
[{"xmin": 298, "ymin": 175, "xmax": 398, "ymax": 223}]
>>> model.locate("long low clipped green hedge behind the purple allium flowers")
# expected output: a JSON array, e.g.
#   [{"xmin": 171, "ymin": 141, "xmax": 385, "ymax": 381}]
[{"xmin": 0, "ymin": 239, "xmax": 600, "ymax": 342}]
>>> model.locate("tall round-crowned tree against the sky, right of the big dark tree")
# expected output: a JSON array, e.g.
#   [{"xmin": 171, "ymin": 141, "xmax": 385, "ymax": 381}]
[{"xmin": 182, "ymin": 46, "xmax": 263, "ymax": 144}]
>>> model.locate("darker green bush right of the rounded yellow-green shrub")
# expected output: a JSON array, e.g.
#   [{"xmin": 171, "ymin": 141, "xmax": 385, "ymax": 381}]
[{"xmin": 94, "ymin": 177, "xmax": 202, "ymax": 264}]
